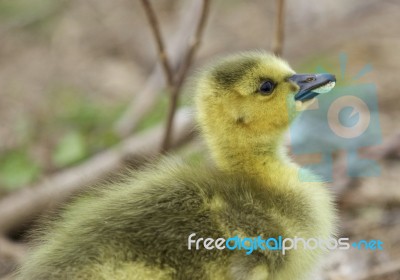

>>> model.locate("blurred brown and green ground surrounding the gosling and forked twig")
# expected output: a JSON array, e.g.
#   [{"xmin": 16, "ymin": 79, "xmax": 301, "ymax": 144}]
[{"xmin": 0, "ymin": 0, "xmax": 400, "ymax": 279}]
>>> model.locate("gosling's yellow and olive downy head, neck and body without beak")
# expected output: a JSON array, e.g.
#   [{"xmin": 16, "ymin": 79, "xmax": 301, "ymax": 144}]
[{"xmin": 19, "ymin": 52, "xmax": 335, "ymax": 280}]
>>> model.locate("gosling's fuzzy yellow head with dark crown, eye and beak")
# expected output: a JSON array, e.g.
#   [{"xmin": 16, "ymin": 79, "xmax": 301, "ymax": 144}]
[{"xmin": 195, "ymin": 52, "xmax": 335, "ymax": 150}]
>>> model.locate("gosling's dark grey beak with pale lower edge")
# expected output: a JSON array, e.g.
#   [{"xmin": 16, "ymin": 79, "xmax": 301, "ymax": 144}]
[{"xmin": 288, "ymin": 74, "xmax": 336, "ymax": 102}]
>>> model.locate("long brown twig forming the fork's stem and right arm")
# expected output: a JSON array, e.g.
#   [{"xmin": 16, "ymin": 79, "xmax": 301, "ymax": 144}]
[{"xmin": 161, "ymin": 0, "xmax": 210, "ymax": 152}]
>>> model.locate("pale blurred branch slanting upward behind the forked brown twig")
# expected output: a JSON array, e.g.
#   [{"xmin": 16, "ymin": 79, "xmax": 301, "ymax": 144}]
[{"xmin": 115, "ymin": 1, "xmax": 202, "ymax": 137}]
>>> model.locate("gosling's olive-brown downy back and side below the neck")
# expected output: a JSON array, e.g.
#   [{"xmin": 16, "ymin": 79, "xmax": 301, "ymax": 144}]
[{"xmin": 19, "ymin": 160, "xmax": 332, "ymax": 279}]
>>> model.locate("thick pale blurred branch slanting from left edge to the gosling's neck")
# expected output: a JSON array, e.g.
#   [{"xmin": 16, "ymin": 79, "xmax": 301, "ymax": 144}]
[{"xmin": 0, "ymin": 109, "xmax": 193, "ymax": 234}]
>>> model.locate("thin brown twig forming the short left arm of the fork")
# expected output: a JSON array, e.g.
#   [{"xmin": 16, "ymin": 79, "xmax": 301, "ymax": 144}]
[{"xmin": 141, "ymin": 0, "xmax": 174, "ymax": 87}]
